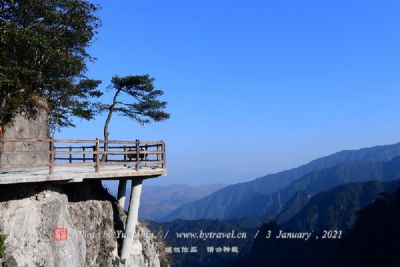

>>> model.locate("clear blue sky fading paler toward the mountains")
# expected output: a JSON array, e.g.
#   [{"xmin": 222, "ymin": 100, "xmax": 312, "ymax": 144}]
[{"xmin": 58, "ymin": 0, "xmax": 400, "ymax": 184}]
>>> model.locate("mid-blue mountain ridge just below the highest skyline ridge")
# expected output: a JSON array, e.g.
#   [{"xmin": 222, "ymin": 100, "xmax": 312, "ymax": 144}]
[{"xmin": 203, "ymin": 157, "xmax": 400, "ymax": 220}]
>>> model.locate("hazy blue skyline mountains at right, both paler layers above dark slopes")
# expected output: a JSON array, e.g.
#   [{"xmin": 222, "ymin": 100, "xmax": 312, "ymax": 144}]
[{"xmin": 164, "ymin": 143, "xmax": 400, "ymax": 220}]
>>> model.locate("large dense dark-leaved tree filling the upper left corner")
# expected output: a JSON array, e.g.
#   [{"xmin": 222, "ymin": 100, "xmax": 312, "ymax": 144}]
[{"xmin": 0, "ymin": 0, "xmax": 101, "ymax": 132}]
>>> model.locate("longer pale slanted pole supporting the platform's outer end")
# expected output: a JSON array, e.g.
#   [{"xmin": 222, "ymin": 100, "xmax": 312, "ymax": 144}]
[{"xmin": 119, "ymin": 178, "xmax": 143, "ymax": 267}]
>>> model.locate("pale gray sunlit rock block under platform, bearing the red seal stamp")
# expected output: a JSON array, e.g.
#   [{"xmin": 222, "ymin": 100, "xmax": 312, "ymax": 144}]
[{"xmin": 0, "ymin": 191, "xmax": 86, "ymax": 266}]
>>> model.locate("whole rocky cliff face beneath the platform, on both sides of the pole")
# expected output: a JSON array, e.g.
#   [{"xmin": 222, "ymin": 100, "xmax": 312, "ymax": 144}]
[{"xmin": 0, "ymin": 181, "xmax": 162, "ymax": 267}]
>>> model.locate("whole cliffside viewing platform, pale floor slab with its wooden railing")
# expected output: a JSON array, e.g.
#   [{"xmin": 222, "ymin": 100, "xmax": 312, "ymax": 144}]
[{"xmin": 0, "ymin": 138, "xmax": 167, "ymax": 184}]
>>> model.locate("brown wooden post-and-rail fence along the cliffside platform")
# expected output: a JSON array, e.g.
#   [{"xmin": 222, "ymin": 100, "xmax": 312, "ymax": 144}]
[{"xmin": 0, "ymin": 138, "xmax": 166, "ymax": 175}]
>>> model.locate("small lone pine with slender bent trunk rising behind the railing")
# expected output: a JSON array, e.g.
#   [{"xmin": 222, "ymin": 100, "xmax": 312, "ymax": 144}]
[{"xmin": 100, "ymin": 75, "xmax": 170, "ymax": 159}]
